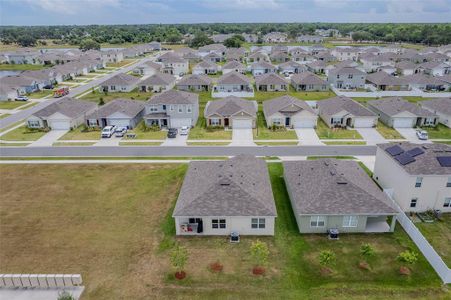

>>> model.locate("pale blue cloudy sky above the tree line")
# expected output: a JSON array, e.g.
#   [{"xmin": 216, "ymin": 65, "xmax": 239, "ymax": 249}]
[{"xmin": 0, "ymin": 0, "xmax": 451, "ymax": 25}]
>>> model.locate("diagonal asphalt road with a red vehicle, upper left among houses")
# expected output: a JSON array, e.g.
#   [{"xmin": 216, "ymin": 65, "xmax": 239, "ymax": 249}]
[{"xmin": 0, "ymin": 56, "xmax": 159, "ymax": 129}]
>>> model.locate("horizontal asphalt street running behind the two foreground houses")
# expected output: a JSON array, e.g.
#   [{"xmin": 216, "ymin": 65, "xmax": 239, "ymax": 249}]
[{"xmin": 0, "ymin": 146, "xmax": 376, "ymax": 157}]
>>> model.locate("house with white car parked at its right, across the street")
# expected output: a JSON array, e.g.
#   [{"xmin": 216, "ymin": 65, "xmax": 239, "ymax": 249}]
[{"xmin": 368, "ymin": 97, "xmax": 438, "ymax": 128}]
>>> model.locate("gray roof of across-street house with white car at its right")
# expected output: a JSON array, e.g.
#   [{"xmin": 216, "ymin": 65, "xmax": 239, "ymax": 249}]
[{"xmin": 368, "ymin": 97, "xmax": 435, "ymax": 117}]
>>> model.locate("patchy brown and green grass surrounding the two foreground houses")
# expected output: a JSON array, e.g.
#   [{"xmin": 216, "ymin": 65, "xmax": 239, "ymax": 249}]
[{"xmin": 0, "ymin": 163, "xmax": 449, "ymax": 300}]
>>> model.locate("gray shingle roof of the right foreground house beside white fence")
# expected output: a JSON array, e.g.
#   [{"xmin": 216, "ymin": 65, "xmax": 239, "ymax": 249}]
[{"xmin": 283, "ymin": 159, "xmax": 396, "ymax": 215}]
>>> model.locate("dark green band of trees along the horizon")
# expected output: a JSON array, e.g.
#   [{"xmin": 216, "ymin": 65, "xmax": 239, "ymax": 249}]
[{"xmin": 0, "ymin": 23, "xmax": 451, "ymax": 47}]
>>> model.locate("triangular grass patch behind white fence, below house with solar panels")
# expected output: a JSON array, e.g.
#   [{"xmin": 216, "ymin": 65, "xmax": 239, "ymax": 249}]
[{"xmin": 415, "ymin": 213, "xmax": 451, "ymax": 267}]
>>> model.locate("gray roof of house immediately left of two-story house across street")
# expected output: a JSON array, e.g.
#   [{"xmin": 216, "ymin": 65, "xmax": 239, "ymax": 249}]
[{"xmin": 87, "ymin": 99, "xmax": 144, "ymax": 119}]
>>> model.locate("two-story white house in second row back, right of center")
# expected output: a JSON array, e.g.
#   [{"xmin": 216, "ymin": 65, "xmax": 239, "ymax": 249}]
[{"xmin": 327, "ymin": 67, "xmax": 367, "ymax": 89}]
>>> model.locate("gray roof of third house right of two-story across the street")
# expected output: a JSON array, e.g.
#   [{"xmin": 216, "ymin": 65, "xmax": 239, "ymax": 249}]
[{"xmin": 318, "ymin": 96, "xmax": 376, "ymax": 117}]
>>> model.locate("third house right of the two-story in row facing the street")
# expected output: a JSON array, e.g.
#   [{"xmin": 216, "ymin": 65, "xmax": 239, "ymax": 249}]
[{"xmin": 318, "ymin": 96, "xmax": 377, "ymax": 128}]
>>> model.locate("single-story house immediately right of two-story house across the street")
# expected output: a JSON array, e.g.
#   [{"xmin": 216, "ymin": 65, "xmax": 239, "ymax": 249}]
[{"xmin": 204, "ymin": 96, "xmax": 258, "ymax": 129}]
